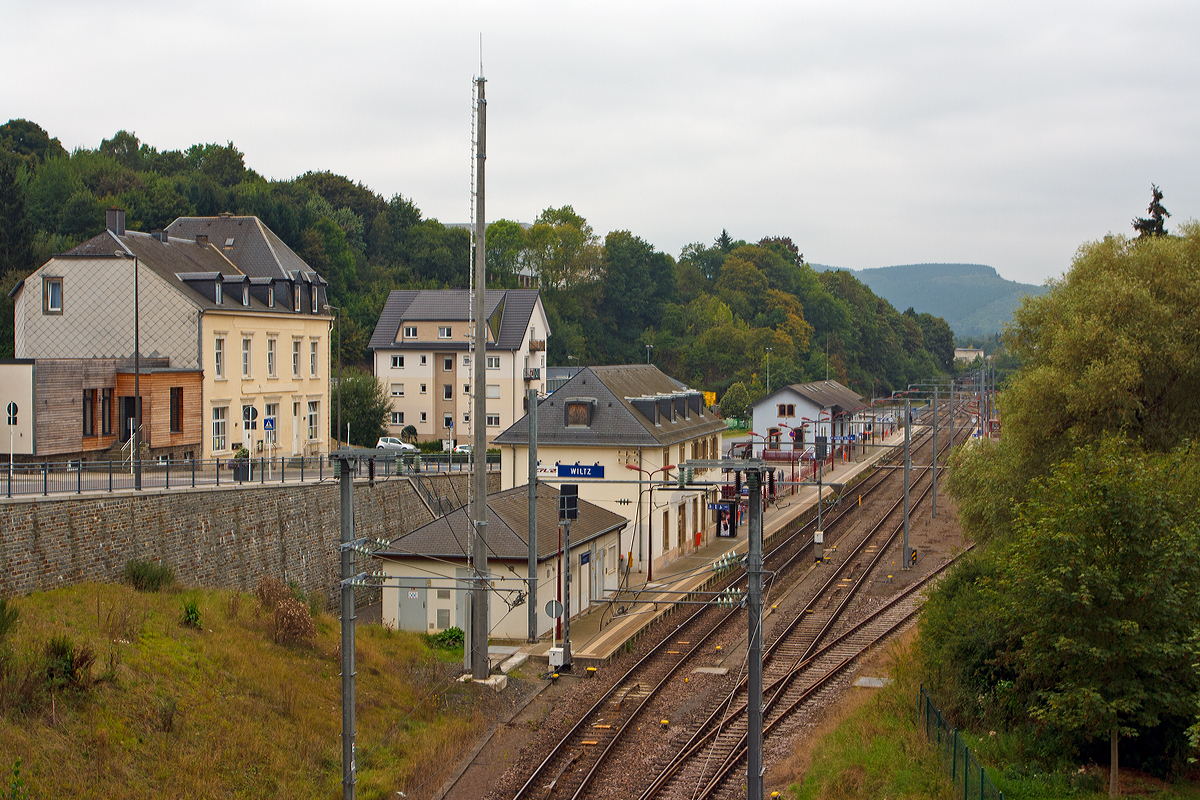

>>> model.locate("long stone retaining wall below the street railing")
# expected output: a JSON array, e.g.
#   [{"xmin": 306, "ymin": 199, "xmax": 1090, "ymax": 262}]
[{"xmin": 0, "ymin": 473, "xmax": 499, "ymax": 602}]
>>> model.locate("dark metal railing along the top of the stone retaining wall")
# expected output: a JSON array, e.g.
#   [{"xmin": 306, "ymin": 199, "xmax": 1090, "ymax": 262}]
[{"xmin": 0, "ymin": 452, "xmax": 500, "ymax": 498}]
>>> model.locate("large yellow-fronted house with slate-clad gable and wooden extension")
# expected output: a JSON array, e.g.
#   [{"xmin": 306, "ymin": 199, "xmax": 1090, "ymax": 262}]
[{"xmin": 13, "ymin": 209, "xmax": 331, "ymax": 458}]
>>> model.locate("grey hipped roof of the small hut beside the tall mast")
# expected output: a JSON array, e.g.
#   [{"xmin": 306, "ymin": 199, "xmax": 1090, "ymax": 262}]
[{"xmin": 376, "ymin": 482, "xmax": 629, "ymax": 561}]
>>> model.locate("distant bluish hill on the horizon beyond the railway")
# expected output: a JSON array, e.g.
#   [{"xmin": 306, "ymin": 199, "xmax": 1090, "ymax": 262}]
[{"xmin": 814, "ymin": 264, "xmax": 1046, "ymax": 336}]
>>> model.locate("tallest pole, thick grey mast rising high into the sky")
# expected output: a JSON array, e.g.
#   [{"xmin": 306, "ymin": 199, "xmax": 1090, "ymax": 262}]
[{"xmin": 470, "ymin": 67, "xmax": 491, "ymax": 680}]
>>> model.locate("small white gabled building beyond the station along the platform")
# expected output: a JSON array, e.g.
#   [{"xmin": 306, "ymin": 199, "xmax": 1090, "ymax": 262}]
[{"xmin": 750, "ymin": 380, "xmax": 871, "ymax": 457}]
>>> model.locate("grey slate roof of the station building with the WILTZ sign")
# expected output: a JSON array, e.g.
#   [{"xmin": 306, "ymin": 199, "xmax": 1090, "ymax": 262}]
[{"xmin": 494, "ymin": 363, "xmax": 725, "ymax": 447}]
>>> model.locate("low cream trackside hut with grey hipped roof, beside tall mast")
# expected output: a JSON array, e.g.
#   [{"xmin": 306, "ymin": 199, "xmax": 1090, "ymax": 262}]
[{"xmin": 376, "ymin": 485, "xmax": 629, "ymax": 639}]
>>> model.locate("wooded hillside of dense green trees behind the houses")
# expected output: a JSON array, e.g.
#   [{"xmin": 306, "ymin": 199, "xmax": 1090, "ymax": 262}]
[{"xmin": 0, "ymin": 120, "xmax": 954, "ymax": 399}]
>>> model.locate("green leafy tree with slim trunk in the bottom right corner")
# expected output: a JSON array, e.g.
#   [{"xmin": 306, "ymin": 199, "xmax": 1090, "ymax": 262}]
[{"xmin": 1009, "ymin": 437, "xmax": 1200, "ymax": 798}]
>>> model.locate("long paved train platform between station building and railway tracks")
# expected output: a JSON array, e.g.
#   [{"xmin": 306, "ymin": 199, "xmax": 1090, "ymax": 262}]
[{"xmin": 520, "ymin": 427, "xmax": 919, "ymax": 674}]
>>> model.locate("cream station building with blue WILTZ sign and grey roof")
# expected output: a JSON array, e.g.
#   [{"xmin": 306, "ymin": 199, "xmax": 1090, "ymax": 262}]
[{"xmin": 496, "ymin": 365, "xmax": 725, "ymax": 578}]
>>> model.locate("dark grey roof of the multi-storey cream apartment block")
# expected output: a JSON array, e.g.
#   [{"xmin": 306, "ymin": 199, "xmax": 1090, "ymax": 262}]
[{"xmin": 368, "ymin": 289, "xmax": 538, "ymax": 350}]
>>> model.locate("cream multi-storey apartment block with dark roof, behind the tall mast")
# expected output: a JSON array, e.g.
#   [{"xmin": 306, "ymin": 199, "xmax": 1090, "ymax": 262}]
[{"xmin": 370, "ymin": 289, "xmax": 550, "ymax": 446}]
